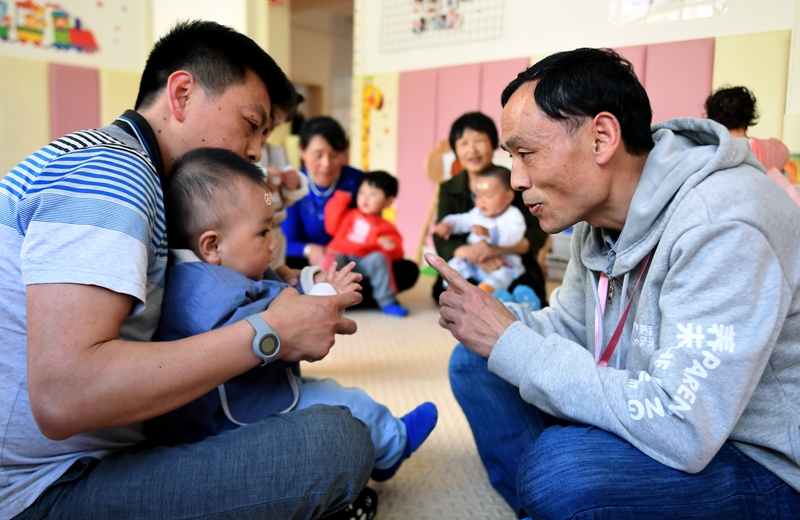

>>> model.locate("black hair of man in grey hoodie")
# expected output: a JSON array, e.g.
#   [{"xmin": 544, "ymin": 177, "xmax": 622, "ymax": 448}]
[{"xmin": 500, "ymin": 48, "xmax": 654, "ymax": 155}]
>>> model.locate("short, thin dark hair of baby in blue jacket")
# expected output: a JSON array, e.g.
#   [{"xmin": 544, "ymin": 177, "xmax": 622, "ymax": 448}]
[{"xmin": 164, "ymin": 148, "xmax": 267, "ymax": 249}]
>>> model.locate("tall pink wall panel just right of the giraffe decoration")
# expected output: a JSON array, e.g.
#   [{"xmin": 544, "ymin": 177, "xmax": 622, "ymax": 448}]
[{"xmin": 396, "ymin": 69, "xmax": 440, "ymax": 256}]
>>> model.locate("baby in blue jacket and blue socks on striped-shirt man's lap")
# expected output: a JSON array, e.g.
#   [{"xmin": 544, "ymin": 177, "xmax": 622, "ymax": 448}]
[{"xmin": 145, "ymin": 148, "xmax": 438, "ymax": 481}]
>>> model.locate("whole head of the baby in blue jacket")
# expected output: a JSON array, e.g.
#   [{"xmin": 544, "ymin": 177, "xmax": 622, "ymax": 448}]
[{"xmin": 164, "ymin": 148, "xmax": 278, "ymax": 280}]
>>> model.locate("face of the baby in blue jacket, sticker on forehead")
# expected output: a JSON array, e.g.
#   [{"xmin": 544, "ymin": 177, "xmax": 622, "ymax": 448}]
[{"xmin": 219, "ymin": 181, "xmax": 278, "ymax": 280}]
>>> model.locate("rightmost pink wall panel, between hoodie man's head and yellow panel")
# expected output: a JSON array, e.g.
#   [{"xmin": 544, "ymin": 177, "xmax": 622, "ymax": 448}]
[{"xmin": 644, "ymin": 38, "xmax": 714, "ymax": 123}]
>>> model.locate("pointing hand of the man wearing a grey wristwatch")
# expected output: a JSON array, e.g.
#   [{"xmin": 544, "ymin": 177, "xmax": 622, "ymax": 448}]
[{"xmin": 261, "ymin": 289, "xmax": 361, "ymax": 361}]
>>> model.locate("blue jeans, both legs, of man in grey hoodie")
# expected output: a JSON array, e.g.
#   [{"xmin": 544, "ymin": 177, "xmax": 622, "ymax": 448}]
[{"xmin": 450, "ymin": 345, "xmax": 800, "ymax": 520}]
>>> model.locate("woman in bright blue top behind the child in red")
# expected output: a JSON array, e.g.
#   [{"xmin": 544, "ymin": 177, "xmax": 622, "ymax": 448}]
[{"xmin": 281, "ymin": 116, "xmax": 419, "ymax": 306}]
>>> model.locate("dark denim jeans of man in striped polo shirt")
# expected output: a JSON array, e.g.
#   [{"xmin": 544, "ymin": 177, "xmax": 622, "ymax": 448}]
[{"xmin": 17, "ymin": 406, "xmax": 375, "ymax": 520}]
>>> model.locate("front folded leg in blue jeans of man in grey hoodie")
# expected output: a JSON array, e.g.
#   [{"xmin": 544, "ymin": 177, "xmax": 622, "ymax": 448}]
[{"xmin": 517, "ymin": 426, "xmax": 800, "ymax": 520}]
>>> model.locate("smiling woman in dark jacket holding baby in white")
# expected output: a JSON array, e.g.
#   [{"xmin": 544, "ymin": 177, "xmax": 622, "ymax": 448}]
[{"xmin": 433, "ymin": 112, "xmax": 547, "ymax": 304}]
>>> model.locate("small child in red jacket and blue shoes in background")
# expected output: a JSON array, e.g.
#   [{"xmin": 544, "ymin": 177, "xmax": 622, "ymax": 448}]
[{"xmin": 322, "ymin": 171, "xmax": 408, "ymax": 317}]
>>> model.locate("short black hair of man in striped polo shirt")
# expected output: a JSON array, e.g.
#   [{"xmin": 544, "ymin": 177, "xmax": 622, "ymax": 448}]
[{"xmin": 134, "ymin": 20, "xmax": 297, "ymax": 119}]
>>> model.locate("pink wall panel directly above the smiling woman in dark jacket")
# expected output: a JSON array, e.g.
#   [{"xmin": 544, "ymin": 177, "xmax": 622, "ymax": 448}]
[{"xmin": 434, "ymin": 63, "xmax": 481, "ymax": 139}]
